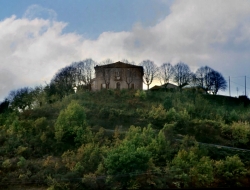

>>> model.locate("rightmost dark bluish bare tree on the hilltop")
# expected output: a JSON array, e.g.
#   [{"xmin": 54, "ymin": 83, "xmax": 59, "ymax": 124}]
[{"xmin": 209, "ymin": 71, "xmax": 227, "ymax": 94}]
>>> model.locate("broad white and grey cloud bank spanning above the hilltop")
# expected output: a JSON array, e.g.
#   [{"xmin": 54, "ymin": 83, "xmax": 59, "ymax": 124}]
[{"xmin": 0, "ymin": 0, "xmax": 250, "ymax": 99}]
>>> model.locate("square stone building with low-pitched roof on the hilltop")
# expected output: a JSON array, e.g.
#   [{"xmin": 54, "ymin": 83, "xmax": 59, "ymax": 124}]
[{"xmin": 92, "ymin": 61, "xmax": 143, "ymax": 90}]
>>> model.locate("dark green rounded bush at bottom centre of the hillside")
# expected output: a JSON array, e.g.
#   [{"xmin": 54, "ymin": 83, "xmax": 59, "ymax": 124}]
[{"xmin": 104, "ymin": 142, "xmax": 151, "ymax": 188}]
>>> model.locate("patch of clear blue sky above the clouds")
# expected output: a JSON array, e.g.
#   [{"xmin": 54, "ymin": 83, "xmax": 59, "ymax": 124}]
[{"xmin": 0, "ymin": 0, "xmax": 172, "ymax": 39}]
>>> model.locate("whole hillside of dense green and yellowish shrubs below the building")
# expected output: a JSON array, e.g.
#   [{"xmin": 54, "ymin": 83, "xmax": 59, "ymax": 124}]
[{"xmin": 0, "ymin": 89, "xmax": 250, "ymax": 189}]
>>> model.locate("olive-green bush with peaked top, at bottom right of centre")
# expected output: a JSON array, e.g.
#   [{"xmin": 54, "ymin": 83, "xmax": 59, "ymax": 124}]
[{"xmin": 166, "ymin": 137, "xmax": 214, "ymax": 187}]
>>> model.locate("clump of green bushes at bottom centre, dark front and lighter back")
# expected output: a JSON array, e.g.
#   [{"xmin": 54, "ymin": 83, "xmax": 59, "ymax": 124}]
[{"xmin": 104, "ymin": 125, "xmax": 170, "ymax": 188}]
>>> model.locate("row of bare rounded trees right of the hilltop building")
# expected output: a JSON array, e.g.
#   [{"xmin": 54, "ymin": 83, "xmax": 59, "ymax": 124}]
[{"xmin": 141, "ymin": 60, "xmax": 227, "ymax": 94}]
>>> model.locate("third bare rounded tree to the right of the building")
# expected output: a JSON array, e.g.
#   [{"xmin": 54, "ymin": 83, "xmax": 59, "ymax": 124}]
[{"xmin": 173, "ymin": 62, "xmax": 191, "ymax": 89}]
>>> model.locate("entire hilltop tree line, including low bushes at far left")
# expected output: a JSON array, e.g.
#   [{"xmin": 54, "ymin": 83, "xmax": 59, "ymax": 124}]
[{"xmin": 0, "ymin": 59, "xmax": 227, "ymax": 113}]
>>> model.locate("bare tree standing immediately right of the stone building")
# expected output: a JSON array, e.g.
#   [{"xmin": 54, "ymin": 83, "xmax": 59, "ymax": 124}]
[{"xmin": 140, "ymin": 60, "xmax": 158, "ymax": 89}]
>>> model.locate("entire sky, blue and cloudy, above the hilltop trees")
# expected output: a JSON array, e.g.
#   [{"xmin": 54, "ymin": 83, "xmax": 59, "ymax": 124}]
[{"xmin": 0, "ymin": 0, "xmax": 250, "ymax": 101}]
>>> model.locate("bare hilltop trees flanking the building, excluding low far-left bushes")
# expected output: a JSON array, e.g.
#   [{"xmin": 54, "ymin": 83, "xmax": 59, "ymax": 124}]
[{"xmin": 48, "ymin": 59, "xmax": 227, "ymax": 94}]
